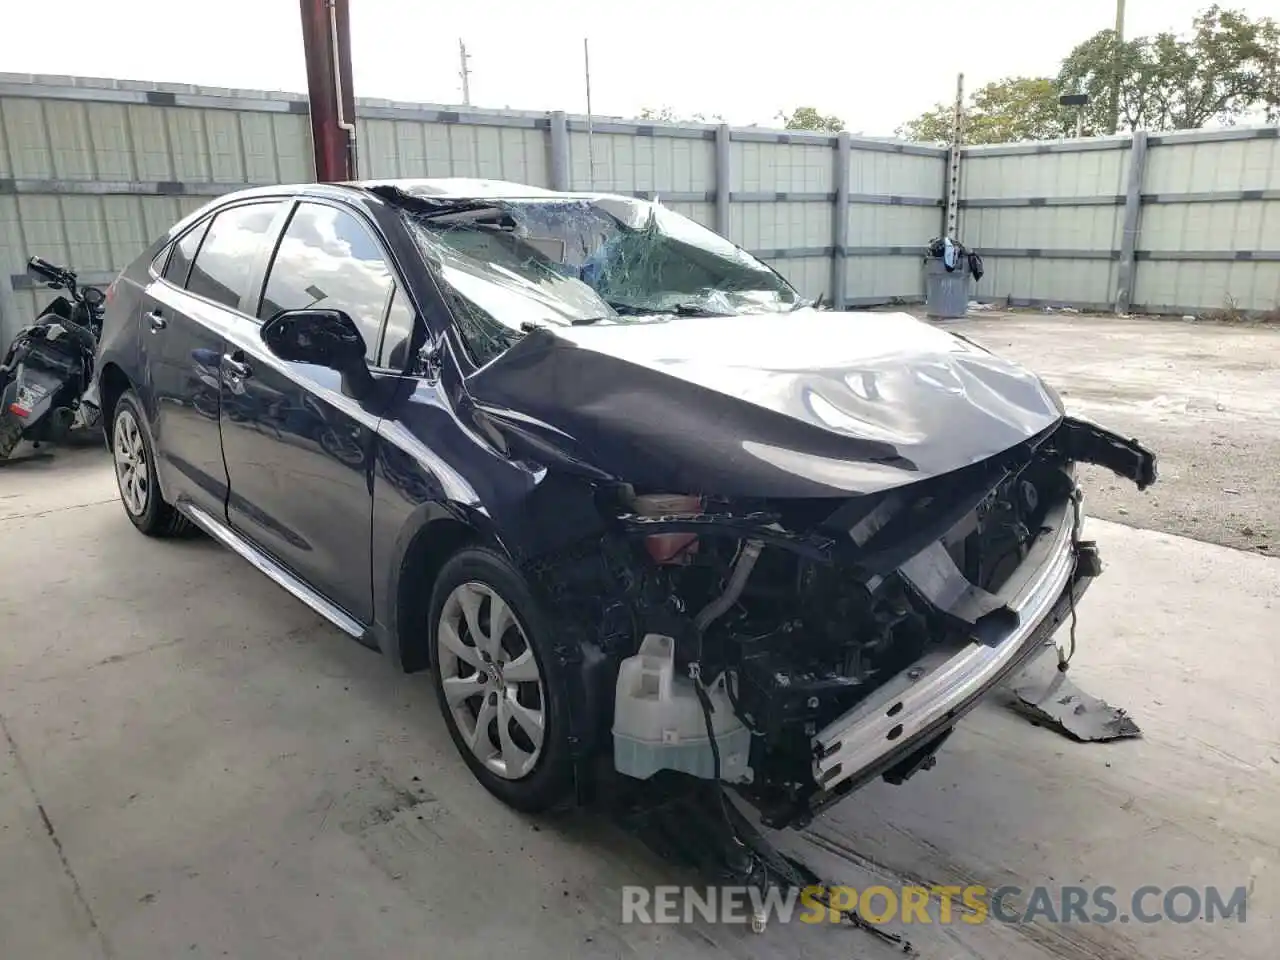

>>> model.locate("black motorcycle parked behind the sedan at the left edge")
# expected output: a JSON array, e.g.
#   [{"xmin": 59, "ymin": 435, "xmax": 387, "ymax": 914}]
[{"xmin": 0, "ymin": 257, "xmax": 106, "ymax": 460}]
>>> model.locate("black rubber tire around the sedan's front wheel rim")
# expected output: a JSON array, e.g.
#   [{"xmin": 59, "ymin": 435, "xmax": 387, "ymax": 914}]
[{"xmin": 428, "ymin": 547, "xmax": 572, "ymax": 813}]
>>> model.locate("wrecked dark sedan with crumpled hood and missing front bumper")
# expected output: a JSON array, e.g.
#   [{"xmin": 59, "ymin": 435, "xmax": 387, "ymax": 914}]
[{"xmin": 87, "ymin": 180, "xmax": 1156, "ymax": 827}]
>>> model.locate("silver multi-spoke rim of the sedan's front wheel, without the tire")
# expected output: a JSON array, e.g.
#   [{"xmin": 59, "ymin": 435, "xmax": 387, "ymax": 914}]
[{"xmin": 435, "ymin": 581, "xmax": 547, "ymax": 780}]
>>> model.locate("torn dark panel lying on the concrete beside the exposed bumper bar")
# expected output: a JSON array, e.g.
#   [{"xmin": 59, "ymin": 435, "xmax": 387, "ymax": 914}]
[{"xmin": 1005, "ymin": 645, "xmax": 1142, "ymax": 742}]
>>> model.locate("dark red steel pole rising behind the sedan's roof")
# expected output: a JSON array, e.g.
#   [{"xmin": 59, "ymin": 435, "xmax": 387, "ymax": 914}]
[{"xmin": 300, "ymin": 0, "xmax": 356, "ymax": 183}]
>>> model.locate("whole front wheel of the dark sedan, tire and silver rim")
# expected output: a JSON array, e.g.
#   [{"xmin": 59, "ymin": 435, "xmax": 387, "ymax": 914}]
[{"xmin": 430, "ymin": 547, "xmax": 571, "ymax": 813}]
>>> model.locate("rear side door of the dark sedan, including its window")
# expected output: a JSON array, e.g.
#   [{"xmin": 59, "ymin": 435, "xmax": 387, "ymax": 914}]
[{"xmin": 141, "ymin": 200, "xmax": 285, "ymax": 518}]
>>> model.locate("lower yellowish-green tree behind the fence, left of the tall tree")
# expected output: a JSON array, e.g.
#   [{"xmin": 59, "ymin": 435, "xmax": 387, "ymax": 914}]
[{"xmin": 896, "ymin": 77, "xmax": 1075, "ymax": 143}]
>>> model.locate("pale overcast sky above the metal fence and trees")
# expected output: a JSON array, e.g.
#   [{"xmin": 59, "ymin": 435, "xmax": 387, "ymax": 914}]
[{"xmin": 0, "ymin": 0, "xmax": 1280, "ymax": 136}]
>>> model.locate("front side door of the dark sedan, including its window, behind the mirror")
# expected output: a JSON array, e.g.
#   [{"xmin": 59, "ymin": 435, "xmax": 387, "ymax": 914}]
[{"xmin": 221, "ymin": 200, "xmax": 396, "ymax": 623}]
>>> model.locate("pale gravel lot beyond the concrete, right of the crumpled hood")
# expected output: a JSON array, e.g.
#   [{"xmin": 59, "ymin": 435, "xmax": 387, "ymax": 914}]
[{"xmin": 931, "ymin": 311, "xmax": 1280, "ymax": 556}]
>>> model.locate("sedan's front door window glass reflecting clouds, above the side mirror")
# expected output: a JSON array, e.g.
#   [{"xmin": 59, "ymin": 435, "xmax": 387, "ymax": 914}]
[{"xmin": 257, "ymin": 204, "xmax": 392, "ymax": 364}]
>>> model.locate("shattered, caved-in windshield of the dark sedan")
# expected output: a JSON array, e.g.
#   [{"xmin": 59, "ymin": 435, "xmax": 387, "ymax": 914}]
[{"xmin": 406, "ymin": 197, "xmax": 800, "ymax": 362}]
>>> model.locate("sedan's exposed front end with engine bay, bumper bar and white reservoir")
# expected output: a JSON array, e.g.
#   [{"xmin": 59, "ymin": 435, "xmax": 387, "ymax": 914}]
[{"xmin": 530, "ymin": 419, "xmax": 1155, "ymax": 826}]
